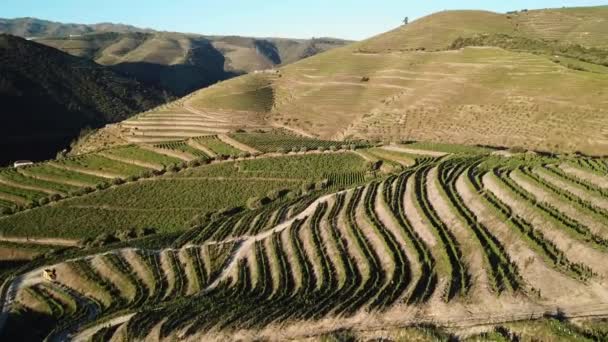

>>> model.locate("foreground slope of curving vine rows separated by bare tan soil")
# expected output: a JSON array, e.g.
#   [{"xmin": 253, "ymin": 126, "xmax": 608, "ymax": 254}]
[{"xmin": 3, "ymin": 144, "xmax": 608, "ymax": 340}]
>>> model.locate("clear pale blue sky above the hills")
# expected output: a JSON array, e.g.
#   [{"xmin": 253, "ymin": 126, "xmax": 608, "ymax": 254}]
[{"xmin": 0, "ymin": 0, "xmax": 607, "ymax": 39}]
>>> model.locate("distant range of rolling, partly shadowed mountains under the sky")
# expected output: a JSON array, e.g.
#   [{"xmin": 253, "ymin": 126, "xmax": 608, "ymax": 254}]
[{"xmin": 0, "ymin": 18, "xmax": 348, "ymax": 96}]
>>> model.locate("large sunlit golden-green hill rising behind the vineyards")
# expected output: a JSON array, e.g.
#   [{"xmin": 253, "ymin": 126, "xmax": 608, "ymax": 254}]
[{"xmin": 108, "ymin": 7, "xmax": 608, "ymax": 154}]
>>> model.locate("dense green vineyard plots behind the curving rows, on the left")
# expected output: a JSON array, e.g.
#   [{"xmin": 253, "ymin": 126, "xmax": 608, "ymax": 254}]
[{"xmin": 0, "ymin": 133, "xmax": 375, "ymax": 239}]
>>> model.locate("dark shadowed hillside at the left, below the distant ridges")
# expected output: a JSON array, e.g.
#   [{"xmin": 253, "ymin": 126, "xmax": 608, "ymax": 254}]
[{"xmin": 0, "ymin": 35, "xmax": 167, "ymax": 164}]
